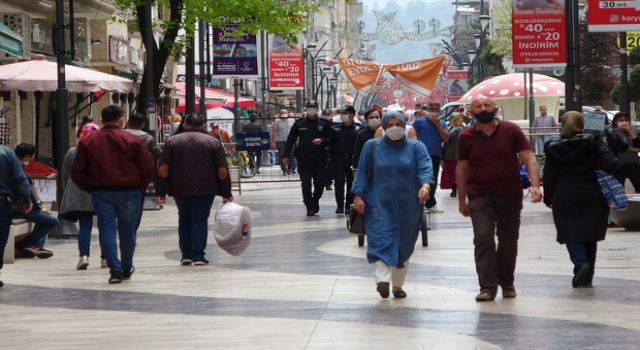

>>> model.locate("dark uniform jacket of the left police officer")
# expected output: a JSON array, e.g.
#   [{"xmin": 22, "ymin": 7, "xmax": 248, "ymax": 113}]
[{"xmin": 283, "ymin": 117, "xmax": 332, "ymax": 160}]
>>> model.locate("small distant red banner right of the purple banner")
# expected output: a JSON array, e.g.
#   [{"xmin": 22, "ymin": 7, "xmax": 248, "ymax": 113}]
[{"xmin": 269, "ymin": 35, "xmax": 304, "ymax": 90}]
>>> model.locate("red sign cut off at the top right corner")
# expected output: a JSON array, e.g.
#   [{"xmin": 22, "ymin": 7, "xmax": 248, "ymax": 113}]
[{"xmin": 587, "ymin": 0, "xmax": 640, "ymax": 32}]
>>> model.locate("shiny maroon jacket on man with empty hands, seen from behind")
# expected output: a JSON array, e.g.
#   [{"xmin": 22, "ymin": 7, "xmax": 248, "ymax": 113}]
[{"xmin": 71, "ymin": 125, "xmax": 155, "ymax": 191}]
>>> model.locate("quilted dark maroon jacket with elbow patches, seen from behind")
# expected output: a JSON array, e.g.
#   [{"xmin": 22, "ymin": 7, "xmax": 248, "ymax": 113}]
[{"xmin": 156, "ymin": 129, "xmax": 231, "ymax": 198}]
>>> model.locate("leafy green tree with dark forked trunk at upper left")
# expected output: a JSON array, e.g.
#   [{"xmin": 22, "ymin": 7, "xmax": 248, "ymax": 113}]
[{"xmin": 115, "ymin": 0, "xmax": 318, "ymax": 112}]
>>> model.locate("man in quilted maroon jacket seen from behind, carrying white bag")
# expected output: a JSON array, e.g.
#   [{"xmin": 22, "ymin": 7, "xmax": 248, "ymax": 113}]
[{"xmin": 156, "ymin": 114, "xmax": 233, "ymax": 265}]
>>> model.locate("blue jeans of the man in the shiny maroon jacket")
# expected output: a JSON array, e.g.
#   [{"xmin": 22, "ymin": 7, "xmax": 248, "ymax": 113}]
[{"xmin": 91, "ymin": 190, "xmax": 142, "ymax": 272}]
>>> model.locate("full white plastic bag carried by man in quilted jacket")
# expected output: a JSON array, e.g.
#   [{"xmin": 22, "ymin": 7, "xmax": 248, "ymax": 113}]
[{"xmin": 214, "ymin": 202, "xmax": 251, "ymax": 256}]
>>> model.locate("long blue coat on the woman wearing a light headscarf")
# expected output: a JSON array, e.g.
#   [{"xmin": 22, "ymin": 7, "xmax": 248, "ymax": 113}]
[{"xmin": 351, "ymin": 138, "xmax": 434, "ymax": 266}]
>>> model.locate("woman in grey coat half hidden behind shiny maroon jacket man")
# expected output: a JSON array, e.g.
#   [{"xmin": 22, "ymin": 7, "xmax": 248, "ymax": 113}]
[{"xmin": 60, "ymin": 126, "xmax": 107, "ymax": 270}]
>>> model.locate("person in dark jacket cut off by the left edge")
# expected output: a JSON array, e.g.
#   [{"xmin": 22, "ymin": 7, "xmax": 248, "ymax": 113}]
[{"xmin": 0, "ymin": 145, "xmax": 33, "ymax": 287}]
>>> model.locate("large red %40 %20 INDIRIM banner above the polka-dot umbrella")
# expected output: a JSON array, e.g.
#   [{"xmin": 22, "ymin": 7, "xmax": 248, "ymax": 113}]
[{"xmin": 511, "ymin": 0, "xmax": 567, "ymax": 68}]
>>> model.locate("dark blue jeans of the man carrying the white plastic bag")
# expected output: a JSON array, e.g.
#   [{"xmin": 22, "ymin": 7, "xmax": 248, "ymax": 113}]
[{"xmin": 174, "ymin": 196, "xmax": 214, "ymax": 261}]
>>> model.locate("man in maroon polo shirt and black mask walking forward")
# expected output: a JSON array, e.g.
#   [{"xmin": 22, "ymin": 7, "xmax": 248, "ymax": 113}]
[{"xmin": 456, "ymin": 98, "xmax": 542, "ymax": 302}]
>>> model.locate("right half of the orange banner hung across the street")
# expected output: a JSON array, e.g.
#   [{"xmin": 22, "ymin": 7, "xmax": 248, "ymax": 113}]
[{"xmin": 385, "ymin": 56, "xmax": 446, "ymax": 96}]
